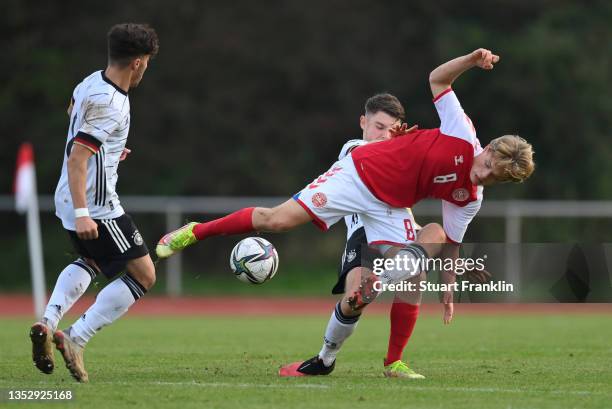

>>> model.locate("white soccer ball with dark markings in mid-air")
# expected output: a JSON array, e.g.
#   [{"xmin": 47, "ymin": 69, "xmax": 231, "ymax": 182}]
[{"xmin": 230, "ymin": 237, "xmax": 278, "ymax": 284}]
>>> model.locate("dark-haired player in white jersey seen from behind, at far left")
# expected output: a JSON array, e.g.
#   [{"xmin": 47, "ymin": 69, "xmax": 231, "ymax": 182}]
[{"xmin": 30, "ymin": 23, "xmax": 159, "ymax": 382}]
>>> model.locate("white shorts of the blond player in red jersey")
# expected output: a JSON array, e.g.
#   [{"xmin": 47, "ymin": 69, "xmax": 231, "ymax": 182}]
[{"xmin": 293, "ymin": 155, "xmax": 417, "ymax": 246}]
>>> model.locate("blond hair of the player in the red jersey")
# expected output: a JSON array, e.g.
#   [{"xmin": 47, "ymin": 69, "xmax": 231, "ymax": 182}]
[{"xmin": 489, "ymin": 135, "xmax": 535, "ymax": 183}]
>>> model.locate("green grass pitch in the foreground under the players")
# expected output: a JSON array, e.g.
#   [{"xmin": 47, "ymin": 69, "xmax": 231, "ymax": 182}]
[{"xmin": 0, "ymin": 314, "xmax": 612, "ymax": 409}]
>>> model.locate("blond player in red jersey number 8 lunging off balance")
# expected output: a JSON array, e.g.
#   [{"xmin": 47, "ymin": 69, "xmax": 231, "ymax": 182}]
[{"xmin": 156, "ymin": 48, "xmax": 535, "ymax": 372}]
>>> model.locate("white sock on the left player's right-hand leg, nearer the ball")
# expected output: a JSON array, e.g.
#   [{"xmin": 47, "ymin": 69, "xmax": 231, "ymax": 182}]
[{"xmin": 70, "ymin": 274, "xmax": 147, "ymax": 347}]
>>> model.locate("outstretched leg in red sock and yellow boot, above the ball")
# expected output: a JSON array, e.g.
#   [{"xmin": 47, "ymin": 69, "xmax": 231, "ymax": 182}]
[{"xmin": 155, "ymin": 199, "xmax": 312, "ymax": 258}]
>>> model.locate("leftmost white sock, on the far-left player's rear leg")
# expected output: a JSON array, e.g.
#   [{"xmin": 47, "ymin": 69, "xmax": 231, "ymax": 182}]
[{"xmin": 43, "ymin": 259, "xmax": 96, "ymax": 332}]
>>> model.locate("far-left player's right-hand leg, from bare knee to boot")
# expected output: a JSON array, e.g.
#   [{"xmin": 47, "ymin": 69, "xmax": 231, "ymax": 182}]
[{"xmin": 53, "ymin": 254, "xmax": 155, "ymax": 382}]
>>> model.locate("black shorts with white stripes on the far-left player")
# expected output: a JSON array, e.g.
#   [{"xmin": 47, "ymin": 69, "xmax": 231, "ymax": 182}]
[{"xmin": 66, "ymin": 214, "xmax": 149, "ymax": 279}]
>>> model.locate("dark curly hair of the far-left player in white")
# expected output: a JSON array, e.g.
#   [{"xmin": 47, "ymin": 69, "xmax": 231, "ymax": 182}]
[{"xmin": 107, "ymin": 23, "xmax": 159, "ymax": 66}]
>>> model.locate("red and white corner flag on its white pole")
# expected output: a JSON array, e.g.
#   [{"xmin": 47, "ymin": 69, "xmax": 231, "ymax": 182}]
[{"xmin": 14, "ymin": 142, "xmax": 45, "ymax": 318}]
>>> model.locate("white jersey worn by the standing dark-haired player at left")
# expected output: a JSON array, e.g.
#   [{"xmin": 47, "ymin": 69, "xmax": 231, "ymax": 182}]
[{"xmin": 55, "ymin": 71, "xmax": 130, "ymax": 230}]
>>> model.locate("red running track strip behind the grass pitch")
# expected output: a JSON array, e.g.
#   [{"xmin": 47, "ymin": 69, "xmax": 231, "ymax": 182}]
[{"xmin": 0, "ymin": 294, "xmax": 612, "ymax": 318}]
